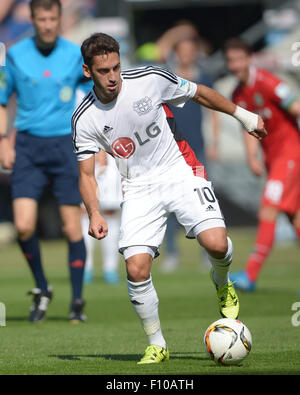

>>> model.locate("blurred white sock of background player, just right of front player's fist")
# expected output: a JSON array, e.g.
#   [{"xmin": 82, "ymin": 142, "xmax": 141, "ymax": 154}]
[{"xmin": 100, "ymin": 212, "xmax": 120, "ymax": 272}]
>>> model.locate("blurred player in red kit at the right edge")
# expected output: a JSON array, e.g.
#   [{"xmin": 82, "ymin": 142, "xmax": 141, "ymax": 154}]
[{"xmin": 225, "ymin": 38, "xmax": 300, "ymax": 291}]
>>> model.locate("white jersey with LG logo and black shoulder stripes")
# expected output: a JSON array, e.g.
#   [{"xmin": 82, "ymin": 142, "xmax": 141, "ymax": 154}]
[{"xmin": 72, "ymin": 66, "xmax": 204, "ymax": 190}]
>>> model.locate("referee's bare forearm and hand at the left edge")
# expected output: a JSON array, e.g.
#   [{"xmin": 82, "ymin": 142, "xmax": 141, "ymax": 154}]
[{"xmin": 0, "ymin": 105, "xmax": 16, "ymax": 170}]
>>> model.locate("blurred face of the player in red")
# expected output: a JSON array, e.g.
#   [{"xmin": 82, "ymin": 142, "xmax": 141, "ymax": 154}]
[{"xmin": 225, "ymin": 49, "xmax": 251, "ymax": 83}]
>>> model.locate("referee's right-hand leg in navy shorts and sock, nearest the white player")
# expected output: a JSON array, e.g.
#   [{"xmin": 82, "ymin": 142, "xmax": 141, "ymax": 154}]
[{"xmin": 47, "ymin": 135, "xmax": 86, "ymax": 322}]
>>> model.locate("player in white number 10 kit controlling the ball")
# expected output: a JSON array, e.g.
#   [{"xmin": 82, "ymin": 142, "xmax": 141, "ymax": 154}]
[{"xmin": 72, "ymin": 33, "xmax": 266, "ymax": 364}]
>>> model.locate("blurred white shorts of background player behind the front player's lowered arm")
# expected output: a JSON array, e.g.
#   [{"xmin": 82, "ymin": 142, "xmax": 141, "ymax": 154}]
[{"xmin": 95, "ymin": 155, "xmax": 122, "ymax": 210}]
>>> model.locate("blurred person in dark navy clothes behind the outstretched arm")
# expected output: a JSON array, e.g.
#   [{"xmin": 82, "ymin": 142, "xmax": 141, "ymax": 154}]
[{"xmin": 161, "ymin": 36, "xmax": 219, "ymax": 272}]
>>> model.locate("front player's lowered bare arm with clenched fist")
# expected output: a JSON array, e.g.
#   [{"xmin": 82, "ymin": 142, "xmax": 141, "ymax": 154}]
[{"xmin": 78, "ymin": 155, "xmax": 108, "ymax": 240}]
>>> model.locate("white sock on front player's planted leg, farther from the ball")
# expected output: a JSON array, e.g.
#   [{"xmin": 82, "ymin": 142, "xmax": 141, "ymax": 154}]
[{"xmin": 127, "ymin": 275, "xmax": 167, "ymax": 348}]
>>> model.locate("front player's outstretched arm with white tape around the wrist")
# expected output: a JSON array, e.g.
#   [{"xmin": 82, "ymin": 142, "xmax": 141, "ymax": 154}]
[{"xmin": 193, "ymin": 84, "xmax": 267, "ymax": 139}]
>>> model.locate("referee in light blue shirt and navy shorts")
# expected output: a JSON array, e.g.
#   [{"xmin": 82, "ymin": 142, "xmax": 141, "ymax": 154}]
[{"xmin": 0, "ymin": 0, "xmax": 90, "ymax": 322}]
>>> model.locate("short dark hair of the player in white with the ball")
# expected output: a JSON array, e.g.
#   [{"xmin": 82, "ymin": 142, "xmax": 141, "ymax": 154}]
[{"xmin": 81, "ymin": 33, "xmax": 120, "ymax": 67}]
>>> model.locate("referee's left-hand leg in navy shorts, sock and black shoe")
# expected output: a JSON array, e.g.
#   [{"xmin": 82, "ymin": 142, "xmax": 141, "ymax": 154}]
[{"xmin": 11, "ymin": 133, "xmax": 52, "ymax": 322}]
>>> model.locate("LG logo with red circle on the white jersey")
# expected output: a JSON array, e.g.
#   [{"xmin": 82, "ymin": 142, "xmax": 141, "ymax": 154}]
[{"xmin": 111, "ymin": 122, "xmax": 161, "ymax": 159}]
